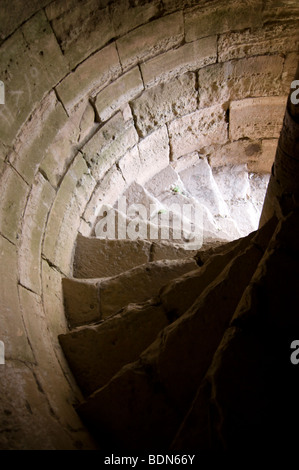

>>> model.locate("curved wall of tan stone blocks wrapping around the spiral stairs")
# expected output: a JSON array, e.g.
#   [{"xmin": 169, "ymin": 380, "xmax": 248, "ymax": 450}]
[{"xmin": 0, "ymin": 0, "xmax": 299, "ymax": 449}]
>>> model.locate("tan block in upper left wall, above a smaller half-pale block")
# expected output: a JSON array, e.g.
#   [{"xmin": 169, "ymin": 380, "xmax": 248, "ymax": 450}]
[{"xmin": 56, "ymin": 43, "xmax": 121, "ymax": 112}]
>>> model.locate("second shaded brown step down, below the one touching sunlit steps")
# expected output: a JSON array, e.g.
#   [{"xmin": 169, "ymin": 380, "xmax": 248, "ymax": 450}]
[{"xmin": 62, "ymin": 258, "xmax": 197, "ymax": 327}]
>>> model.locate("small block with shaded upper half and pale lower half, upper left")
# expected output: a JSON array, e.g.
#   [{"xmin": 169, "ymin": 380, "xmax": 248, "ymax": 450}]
[{"xmin": 95, "ymin": 67, "xmax": 143, "ymax": 121}]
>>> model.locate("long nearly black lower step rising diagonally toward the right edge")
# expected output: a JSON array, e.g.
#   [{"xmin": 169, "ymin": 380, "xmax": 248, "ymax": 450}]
[{"xmin": 77, "ymin": 217, "xmax": 273, "ymax": 451}]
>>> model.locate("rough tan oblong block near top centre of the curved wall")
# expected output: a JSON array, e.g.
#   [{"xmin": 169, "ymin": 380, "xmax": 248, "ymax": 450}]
[{"xmin": 117, "ymin": 12, "xmax": 184, "ymax": 70}]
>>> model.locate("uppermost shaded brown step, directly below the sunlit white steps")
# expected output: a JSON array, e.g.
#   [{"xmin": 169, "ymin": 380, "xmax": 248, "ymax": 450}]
[{"xmin": 73, "ymin": 234, "xmax": 198, "ymax": 279}]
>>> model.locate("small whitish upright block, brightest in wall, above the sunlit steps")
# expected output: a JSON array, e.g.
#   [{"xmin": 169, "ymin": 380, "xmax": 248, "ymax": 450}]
[{"xmin": 137, "ymin": 125, "xmax": 169, "ymax": 184}]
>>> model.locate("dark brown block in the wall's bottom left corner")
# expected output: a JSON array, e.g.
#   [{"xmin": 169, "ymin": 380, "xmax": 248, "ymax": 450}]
[{"xmin": 0, "ymin": 361, "xmax": 85, "ymax": 450}]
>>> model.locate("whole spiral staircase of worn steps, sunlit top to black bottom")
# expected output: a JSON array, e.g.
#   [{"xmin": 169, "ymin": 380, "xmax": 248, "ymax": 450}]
[{"xmin": 59, "ymin": 160, "xmax": 298, "ymax": 452}]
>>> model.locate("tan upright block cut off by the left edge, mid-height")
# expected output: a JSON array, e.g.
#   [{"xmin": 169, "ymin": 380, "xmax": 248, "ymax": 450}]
[{"xmin": 0, "ymin": 164, "xmax": 29, "ymax": 243}]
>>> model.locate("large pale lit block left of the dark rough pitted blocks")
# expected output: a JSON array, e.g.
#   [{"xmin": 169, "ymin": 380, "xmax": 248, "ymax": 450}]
[{"xmin": 82, "ymin": 112, "xmax": 138, "ymax": 181}]
